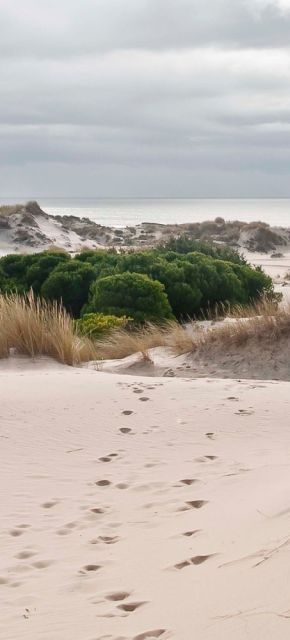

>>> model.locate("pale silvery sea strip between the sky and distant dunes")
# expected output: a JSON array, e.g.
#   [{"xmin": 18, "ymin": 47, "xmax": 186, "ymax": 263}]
[{"xmin": 3, "ymin": 197, "xmax": 290, "ymax": 228}]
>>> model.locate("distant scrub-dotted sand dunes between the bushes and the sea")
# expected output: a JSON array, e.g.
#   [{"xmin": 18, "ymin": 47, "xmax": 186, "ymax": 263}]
[{"xmin": 0, "ymin": 202, "xmax": 290, "ymax": 253}]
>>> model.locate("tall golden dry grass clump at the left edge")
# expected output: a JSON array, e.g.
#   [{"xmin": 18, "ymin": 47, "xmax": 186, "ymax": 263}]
[{"xmin": 0, "ymin": 293, "xmax": 96, "ymax": 365}]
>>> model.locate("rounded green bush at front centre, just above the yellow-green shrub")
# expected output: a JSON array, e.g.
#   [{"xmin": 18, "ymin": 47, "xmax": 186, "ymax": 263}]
[{"xmin": 90, "ymin": 273, "xmax": 173, "ymax": 323}]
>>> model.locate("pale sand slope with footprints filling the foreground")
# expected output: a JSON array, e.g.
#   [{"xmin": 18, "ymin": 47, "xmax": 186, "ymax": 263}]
[{"xmin": 0, "ymin": 365, "xmax": 290, "ymax": 640}]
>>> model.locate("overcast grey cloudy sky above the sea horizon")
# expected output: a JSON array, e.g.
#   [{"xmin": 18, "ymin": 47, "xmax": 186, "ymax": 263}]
[{"xmin": 0, "ymin": 0, "xmax": 290, "ymax": 201}]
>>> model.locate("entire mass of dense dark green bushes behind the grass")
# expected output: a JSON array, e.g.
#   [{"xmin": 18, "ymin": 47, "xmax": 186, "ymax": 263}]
[{"xmin": 0, "ymin": 238, "xmax": 275, "ymax": 322}]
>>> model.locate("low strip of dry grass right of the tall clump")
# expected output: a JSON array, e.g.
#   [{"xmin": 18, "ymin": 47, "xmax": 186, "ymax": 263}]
[{"xmin": 97, "ymin": 301, "xmax": 290, "ymax": 361}]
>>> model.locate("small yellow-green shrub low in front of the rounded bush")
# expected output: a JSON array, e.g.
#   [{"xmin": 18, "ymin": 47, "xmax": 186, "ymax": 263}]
[{"xmin": 75, "ymin": 313, "xmax": 130, "ymax": 339}]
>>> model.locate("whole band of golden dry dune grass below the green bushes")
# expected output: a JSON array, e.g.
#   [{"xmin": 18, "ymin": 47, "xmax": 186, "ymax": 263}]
[{"xmin": 0, "ymin": 293, "xmax": 290, "ymax": 365}]
